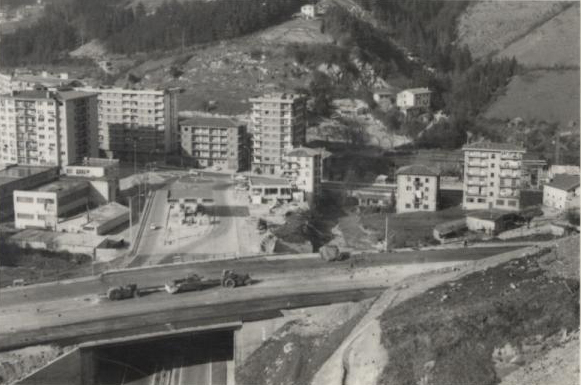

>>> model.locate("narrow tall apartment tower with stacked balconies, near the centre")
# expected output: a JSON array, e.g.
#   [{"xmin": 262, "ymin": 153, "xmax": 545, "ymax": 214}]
[{"xmin": 250, "ymin": 93, "xmax": 306, "ymax": 175}]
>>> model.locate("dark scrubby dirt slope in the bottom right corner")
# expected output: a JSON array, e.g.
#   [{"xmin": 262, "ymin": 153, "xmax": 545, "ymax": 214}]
[{"xmin": 380, "ymin": 237, "xmax": 579, "ymax": 385}]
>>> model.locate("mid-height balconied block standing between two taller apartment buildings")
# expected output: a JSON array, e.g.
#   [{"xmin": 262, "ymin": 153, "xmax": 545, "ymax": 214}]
[{"xmin": 179, "ymin": 116, "xmax": 250, "ymax": 171}]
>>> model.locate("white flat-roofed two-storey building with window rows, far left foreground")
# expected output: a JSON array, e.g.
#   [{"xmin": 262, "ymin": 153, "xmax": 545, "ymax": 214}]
[{"xmin": 14, "ymin": 180, "xmax": 90, "ymax": 230}]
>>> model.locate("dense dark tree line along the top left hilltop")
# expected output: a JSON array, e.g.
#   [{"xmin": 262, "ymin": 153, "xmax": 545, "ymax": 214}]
[{"xmin": 0, "ymin": 0, "xmax": 305, "ymax": 66}]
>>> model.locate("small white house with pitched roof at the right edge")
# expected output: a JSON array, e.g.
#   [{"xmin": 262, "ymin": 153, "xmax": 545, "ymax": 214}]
[{"xmin": 543, "ymin": 174, "xmax": 579, "ymax": 211}]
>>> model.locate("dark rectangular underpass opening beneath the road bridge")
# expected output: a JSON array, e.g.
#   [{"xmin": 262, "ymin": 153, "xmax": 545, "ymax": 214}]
[{"xmin": 90, "ymin": 330, "xmax": 235, "ymax": 385}]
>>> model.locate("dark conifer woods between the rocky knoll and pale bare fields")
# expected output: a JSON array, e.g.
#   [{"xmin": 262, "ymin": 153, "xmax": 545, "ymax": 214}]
[{"xmin": 323, "ymin": 4, "xmax": 519, "ymax": 148}]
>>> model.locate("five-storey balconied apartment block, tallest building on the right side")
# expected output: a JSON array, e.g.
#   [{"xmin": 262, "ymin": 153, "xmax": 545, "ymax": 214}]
[{"xmin": 462, "ymin": 142, "xmax": 525, "ymax": 210}]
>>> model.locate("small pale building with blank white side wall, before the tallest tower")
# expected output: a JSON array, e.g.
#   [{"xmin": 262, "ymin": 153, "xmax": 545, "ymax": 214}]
[{"xmin": 283, "ymin": 147, "xmax": 323, "ymax": 201}]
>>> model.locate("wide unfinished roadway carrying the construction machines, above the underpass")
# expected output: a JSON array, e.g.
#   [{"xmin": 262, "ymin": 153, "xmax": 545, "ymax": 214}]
[{"xmin": 0, "ymin": 248, "xmax": 514, "ymax": 350}]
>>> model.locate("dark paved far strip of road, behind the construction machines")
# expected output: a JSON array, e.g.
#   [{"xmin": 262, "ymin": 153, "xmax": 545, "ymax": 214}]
[{"xmin": 0, "ymin": 246, "xmax": 515, "ymax": 306}]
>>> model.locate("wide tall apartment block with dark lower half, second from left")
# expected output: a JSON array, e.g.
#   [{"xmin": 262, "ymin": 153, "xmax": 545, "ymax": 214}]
[{"xmin": 80, "ymin": 88, "xmax": 179, "ymax": 159}]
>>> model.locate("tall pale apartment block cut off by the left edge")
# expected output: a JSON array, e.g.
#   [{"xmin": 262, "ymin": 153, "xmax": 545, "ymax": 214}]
[{"xmin": 0, "ymin": 91, "xmax": 98, "ymax": 167}]
